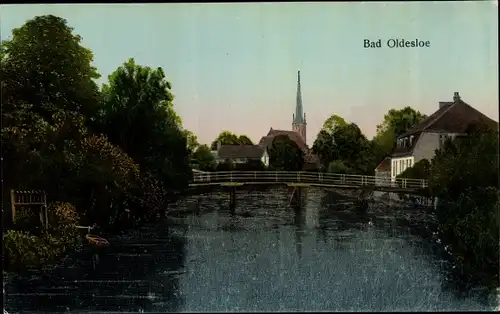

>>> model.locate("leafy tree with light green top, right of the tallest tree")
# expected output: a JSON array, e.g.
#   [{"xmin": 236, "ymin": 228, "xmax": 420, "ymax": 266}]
[{"xmin": 97, "ymin": 59, "xmax": 190, "ymax": 188}]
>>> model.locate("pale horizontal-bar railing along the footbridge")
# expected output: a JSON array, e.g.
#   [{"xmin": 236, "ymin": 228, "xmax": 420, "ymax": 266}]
[{"xmin": 194, "ymin": 171, "xmax": 428, "ymax": 189}]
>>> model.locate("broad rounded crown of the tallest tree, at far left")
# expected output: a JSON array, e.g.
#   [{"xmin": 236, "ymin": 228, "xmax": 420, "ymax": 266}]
[{"xmin": 1, "ymin": 15, "xmax": 99, "ymax": 122}]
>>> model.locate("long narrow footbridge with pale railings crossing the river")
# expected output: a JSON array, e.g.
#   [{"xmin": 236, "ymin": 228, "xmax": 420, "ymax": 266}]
[{"xmin": 190, "ymin": 170, "xmax": 428, "ymax": 194}]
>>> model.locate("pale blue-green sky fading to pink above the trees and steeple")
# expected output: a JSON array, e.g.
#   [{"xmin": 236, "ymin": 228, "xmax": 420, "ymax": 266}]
[{"xmin": 0, "ymin": 1, "xmax": 498, "ymax": 144}]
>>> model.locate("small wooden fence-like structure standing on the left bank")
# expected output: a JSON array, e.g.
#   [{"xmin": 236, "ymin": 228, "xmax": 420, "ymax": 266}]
[{"xmin": 10, "ymin": 190, "xmax": 49, "ymax": 229}]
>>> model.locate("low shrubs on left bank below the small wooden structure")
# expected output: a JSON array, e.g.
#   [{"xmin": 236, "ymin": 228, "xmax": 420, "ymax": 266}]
[{"xmin": 4, "ymin": 202, "xmax": 79, "ymax": 271}]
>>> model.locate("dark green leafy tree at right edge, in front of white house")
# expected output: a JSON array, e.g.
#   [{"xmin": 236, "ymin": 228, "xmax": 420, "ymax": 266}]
[{"xmin": 429, "ymin": 128, "xmax": 500, "ymax": 287}]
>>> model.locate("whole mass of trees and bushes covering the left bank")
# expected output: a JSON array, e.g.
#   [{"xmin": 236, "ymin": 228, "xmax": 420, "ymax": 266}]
[{"xmin": 0, "ymin": 15, "xmax": 193, "ymax": 265}]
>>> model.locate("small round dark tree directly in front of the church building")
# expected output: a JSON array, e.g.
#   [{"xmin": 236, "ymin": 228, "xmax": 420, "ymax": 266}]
[{"xmin": 269, "ymin": 135, "xmax": 304, "ymax": 171}]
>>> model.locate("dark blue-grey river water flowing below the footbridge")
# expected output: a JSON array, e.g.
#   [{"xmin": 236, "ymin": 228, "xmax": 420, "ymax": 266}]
[{"xmin": 5, "ymin": 188, "xmax": 498, "ymax": 313}]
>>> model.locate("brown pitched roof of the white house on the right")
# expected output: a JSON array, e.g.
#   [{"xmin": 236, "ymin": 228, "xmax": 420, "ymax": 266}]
[{"xmin": 392, "ymin": 93, "xmax": 498, "ymax": 157}]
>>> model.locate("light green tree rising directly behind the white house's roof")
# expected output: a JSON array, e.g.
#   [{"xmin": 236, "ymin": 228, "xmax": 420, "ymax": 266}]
[{"xmin": 373, "ymin": 106, "xmax": 426, "ymax": 161}]
